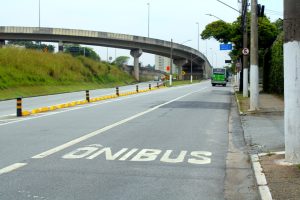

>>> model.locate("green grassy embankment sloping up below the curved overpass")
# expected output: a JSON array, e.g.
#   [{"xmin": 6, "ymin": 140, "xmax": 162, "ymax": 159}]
[{"xmin": 0, "ymin": 48, "xmax": 134, "ymax": 100}]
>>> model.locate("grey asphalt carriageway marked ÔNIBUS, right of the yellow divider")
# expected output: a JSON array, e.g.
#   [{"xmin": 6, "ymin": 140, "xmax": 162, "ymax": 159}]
[{"xmin": 0, "ymin": 81, "xmax": 232, "ymax": 200}]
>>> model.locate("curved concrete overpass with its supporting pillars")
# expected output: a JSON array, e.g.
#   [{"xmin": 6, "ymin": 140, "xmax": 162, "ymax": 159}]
[{"xmin": 0, "ymin": 26, "xmax": 211, "ymax": 80}]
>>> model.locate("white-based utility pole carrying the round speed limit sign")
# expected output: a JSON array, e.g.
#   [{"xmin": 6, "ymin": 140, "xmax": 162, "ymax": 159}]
[{"xmin": 242, "ymin": 0, "xmax": 249, "ymax": 97}]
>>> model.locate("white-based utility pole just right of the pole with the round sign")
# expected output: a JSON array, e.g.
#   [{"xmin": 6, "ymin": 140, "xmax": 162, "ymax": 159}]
[{"xmin": 250, "ymin": 0, "xmax": 259, "ymax": 111}]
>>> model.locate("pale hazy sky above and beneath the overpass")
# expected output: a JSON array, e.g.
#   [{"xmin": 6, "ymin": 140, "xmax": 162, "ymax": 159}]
[{"xmin": 0, "ymin": 0, "xmax": 283, "ymax": 67}]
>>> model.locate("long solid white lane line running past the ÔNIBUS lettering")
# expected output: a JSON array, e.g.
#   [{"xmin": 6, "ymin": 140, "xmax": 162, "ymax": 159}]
[{"xmin": 32, "ymin": 87, "xmax": 207, "ymax": 158}]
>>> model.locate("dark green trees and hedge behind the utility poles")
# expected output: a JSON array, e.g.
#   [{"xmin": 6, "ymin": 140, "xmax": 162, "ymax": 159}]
[{"xmin": 201, "ymin": 13, "xmax": 284, "ymax": 95}]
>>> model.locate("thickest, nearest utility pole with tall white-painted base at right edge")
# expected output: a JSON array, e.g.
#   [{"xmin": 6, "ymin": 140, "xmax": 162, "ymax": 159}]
[{"xmin": 283, "ymin": 0, "xmax": 300, "ymax": 164}]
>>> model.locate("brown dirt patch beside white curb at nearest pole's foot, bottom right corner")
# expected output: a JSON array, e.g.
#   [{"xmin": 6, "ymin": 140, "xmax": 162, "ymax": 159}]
[{"xmin": 260, "ymin": 155, "xmax": 300, "ymax": 200}]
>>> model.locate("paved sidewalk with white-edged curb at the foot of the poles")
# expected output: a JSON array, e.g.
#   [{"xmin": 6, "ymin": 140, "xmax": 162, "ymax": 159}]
[{"xmin": 238, "ymin": 94, "xmax": 300, "ymax": 200}]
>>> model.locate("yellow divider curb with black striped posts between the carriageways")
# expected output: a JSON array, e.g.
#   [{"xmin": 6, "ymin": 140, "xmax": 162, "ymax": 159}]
[{"xmin": 17, "ymin": 85, "xmax": 165, "ymax": 117}]
